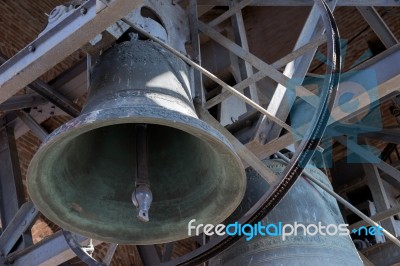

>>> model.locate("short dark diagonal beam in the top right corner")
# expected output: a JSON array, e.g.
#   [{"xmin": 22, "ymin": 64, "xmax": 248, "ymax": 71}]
[{"xmin": 357, "ymin": 6, "xmax": 399, "ymax": 48}]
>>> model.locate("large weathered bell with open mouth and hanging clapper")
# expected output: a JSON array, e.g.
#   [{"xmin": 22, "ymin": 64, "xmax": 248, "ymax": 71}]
[{"xmin": 28, "ymin": 40, "xmax": 246, "ymax": 245}]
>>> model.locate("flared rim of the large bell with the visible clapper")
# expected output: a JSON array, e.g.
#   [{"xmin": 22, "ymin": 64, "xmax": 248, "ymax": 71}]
[{"xmin": 27, "ymin": 106, "xmax": 247, "ymax": 245}]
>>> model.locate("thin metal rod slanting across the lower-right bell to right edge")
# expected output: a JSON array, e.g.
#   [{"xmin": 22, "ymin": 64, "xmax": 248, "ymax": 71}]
[{"xmin": 276, "ymin": 152, "xmax": 400, "ymax": 247}]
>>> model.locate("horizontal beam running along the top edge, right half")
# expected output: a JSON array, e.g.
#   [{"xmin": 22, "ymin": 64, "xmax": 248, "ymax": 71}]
[{"xmin": 198, "ymin": 0, "xmax": 400, "ymax": 6}]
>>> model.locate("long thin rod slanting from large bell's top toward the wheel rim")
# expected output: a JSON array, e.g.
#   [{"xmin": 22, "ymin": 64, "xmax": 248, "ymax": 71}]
[{"xmin": 121, "ymin": 18, "xmax": 293, "ymax": 132}]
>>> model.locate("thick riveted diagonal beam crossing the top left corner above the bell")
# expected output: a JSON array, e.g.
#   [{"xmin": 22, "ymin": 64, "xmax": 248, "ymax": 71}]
[{"xmin": 0, "ymin": 0, "xmax": 143, "ymax": 103}]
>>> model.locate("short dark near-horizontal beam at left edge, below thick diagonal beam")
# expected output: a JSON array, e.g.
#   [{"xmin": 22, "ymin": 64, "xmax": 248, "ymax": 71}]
[{"xmin": 0, "ymin": 93, "xmax": 47, "ymax": 112}]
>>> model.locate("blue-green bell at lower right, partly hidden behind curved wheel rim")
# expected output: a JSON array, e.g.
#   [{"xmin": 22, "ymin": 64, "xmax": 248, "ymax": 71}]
[{"xmin": 210, "ymin": 160, "xmax": 363, "ymax": 266}]
